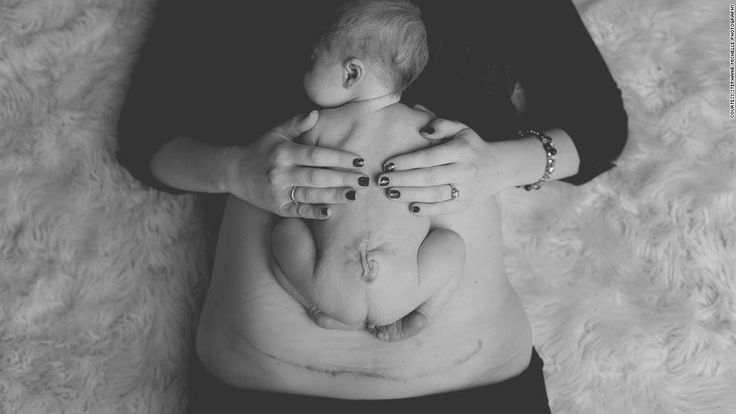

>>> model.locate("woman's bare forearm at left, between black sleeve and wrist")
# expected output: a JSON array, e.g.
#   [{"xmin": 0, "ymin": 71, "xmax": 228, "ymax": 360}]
[{"xmin": 150, "ymin": 138, "xmax": 228, "ymax": 193}]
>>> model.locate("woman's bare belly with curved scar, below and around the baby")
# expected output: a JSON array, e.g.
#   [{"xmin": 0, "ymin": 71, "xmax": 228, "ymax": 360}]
[{"xmin": 197, "ymin": 197, "xmax": 531, "ymax": 399}]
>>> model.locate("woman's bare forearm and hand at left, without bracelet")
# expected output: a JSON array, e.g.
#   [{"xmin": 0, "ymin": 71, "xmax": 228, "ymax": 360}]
[{"xmin": 139, "ymin": 111, "xmax": 363, "ymax": 219}]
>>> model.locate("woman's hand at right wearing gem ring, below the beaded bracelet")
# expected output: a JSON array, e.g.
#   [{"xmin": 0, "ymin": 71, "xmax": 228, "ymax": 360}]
[{"xmin": 379, "ymin": 107, "xmax": 503, "ymax": 216}]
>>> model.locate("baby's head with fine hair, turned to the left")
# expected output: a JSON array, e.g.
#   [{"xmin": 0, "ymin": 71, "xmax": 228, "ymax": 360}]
[{"xmin": 304, "ymin": 0, "xmax": 429, "ymax": 107}]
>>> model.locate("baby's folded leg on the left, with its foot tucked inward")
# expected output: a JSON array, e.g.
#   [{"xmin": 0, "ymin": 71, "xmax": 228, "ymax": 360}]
[{"xmin": 271, "ymin": 218, "xmax": 363, "ymax": 329}]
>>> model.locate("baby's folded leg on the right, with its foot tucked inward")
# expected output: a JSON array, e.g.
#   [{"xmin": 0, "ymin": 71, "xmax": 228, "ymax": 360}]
[{"xmin": 368, "ymin": 229, "xmax": 465, "ymax": 342}]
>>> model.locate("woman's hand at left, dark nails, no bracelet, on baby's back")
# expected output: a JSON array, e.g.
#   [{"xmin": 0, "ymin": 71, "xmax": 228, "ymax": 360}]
[{"xmin": 222, "ymin": 111, "xmax": 365, "ymax": 219}]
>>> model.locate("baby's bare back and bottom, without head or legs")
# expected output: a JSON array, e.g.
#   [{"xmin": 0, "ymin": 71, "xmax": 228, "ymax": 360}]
[{"xmin": 300, "ymin": 103, "xmax": 430, "ymax": 325}]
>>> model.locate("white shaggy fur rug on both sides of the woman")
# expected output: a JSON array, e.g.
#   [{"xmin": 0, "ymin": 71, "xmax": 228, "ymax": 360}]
[{"xmin": 0, "ymin": 0, "xmax": 736, "ymax": 414}]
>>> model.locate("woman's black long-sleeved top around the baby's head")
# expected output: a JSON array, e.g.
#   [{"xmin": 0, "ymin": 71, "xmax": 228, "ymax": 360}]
[{"xmin": 117, "ymin": 0, "xmax": 627, "ymax": 204}]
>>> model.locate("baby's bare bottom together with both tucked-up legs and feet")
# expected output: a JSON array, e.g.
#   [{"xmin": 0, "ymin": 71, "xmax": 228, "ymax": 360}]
[{"xmin": 272, "ymin": 219, "xmax": 465, "ymax": 341}]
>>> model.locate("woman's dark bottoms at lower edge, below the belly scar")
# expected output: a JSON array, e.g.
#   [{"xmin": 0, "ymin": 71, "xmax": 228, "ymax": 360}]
[{"xmin": 188, "ymin": 350, "xmax": 550, "ymax": 414}]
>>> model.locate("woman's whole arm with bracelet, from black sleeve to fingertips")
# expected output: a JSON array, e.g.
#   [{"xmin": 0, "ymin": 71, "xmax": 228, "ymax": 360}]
[{"xmin": 379, "ymin": 0, "xmax": 627, "ymax": 215}]
